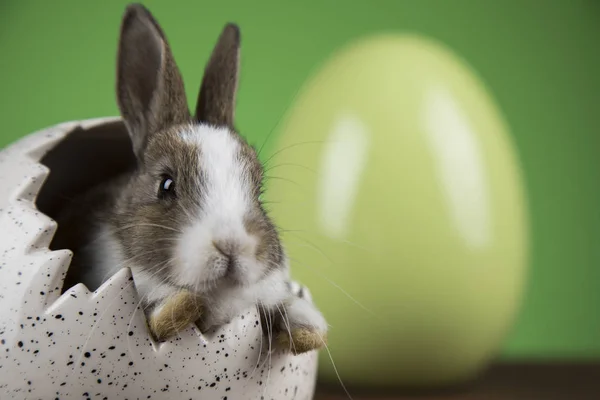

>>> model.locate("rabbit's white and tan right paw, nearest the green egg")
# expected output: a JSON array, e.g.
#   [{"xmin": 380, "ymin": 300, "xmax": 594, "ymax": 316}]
[{"xmin": 276, "ymin": 284, "xmax": 327, "ymax": 355}]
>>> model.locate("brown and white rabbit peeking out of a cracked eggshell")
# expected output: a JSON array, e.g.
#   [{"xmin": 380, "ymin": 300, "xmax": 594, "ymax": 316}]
[{"xmin": 55, "ymin": 3, "xmax": 327, "ymax": 354}]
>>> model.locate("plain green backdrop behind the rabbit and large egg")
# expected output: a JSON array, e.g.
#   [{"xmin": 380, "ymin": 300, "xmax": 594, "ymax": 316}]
[{"xmin": 0, "ymin": 0, "xmax": 600, "ymax": 358}]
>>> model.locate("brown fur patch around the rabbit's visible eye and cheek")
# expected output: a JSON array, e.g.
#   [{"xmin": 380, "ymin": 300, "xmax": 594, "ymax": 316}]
[{"xmin": 110, "ymin": 126, "xmax": 204, "ymax": 282}]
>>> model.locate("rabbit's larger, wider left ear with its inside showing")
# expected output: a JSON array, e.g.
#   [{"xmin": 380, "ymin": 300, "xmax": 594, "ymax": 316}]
[{"xmin": 117, "ymin": 4, "xmax": 190, "ymax": 158}]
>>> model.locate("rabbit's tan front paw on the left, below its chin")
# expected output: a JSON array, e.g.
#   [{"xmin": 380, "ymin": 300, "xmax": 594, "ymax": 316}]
[{"xmin": 148, "ymin": 290, "xmax": 201, "ymax": 341}]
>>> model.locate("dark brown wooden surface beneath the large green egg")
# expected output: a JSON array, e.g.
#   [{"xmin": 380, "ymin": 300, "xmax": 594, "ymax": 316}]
[{"xmin": 314, "ymin": 361, "xmax": 600, "ymax": 400}]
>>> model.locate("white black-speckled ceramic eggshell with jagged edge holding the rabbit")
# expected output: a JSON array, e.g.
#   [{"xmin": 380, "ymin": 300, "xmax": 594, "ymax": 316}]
[{"xmin": 0, "ymin": 118, "xmax": 318, "ymax": 400}]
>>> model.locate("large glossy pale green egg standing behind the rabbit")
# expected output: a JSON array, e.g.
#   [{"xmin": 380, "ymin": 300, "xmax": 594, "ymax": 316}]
[{"xmin": 266, "ymin": 35, "xmax": 528, "ymax": 385}]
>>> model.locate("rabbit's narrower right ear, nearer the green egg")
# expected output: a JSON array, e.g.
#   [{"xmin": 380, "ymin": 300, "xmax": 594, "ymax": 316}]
[{"xmin": 195, "ymin": 24, "xmax": 240, "ymax": 128}]
